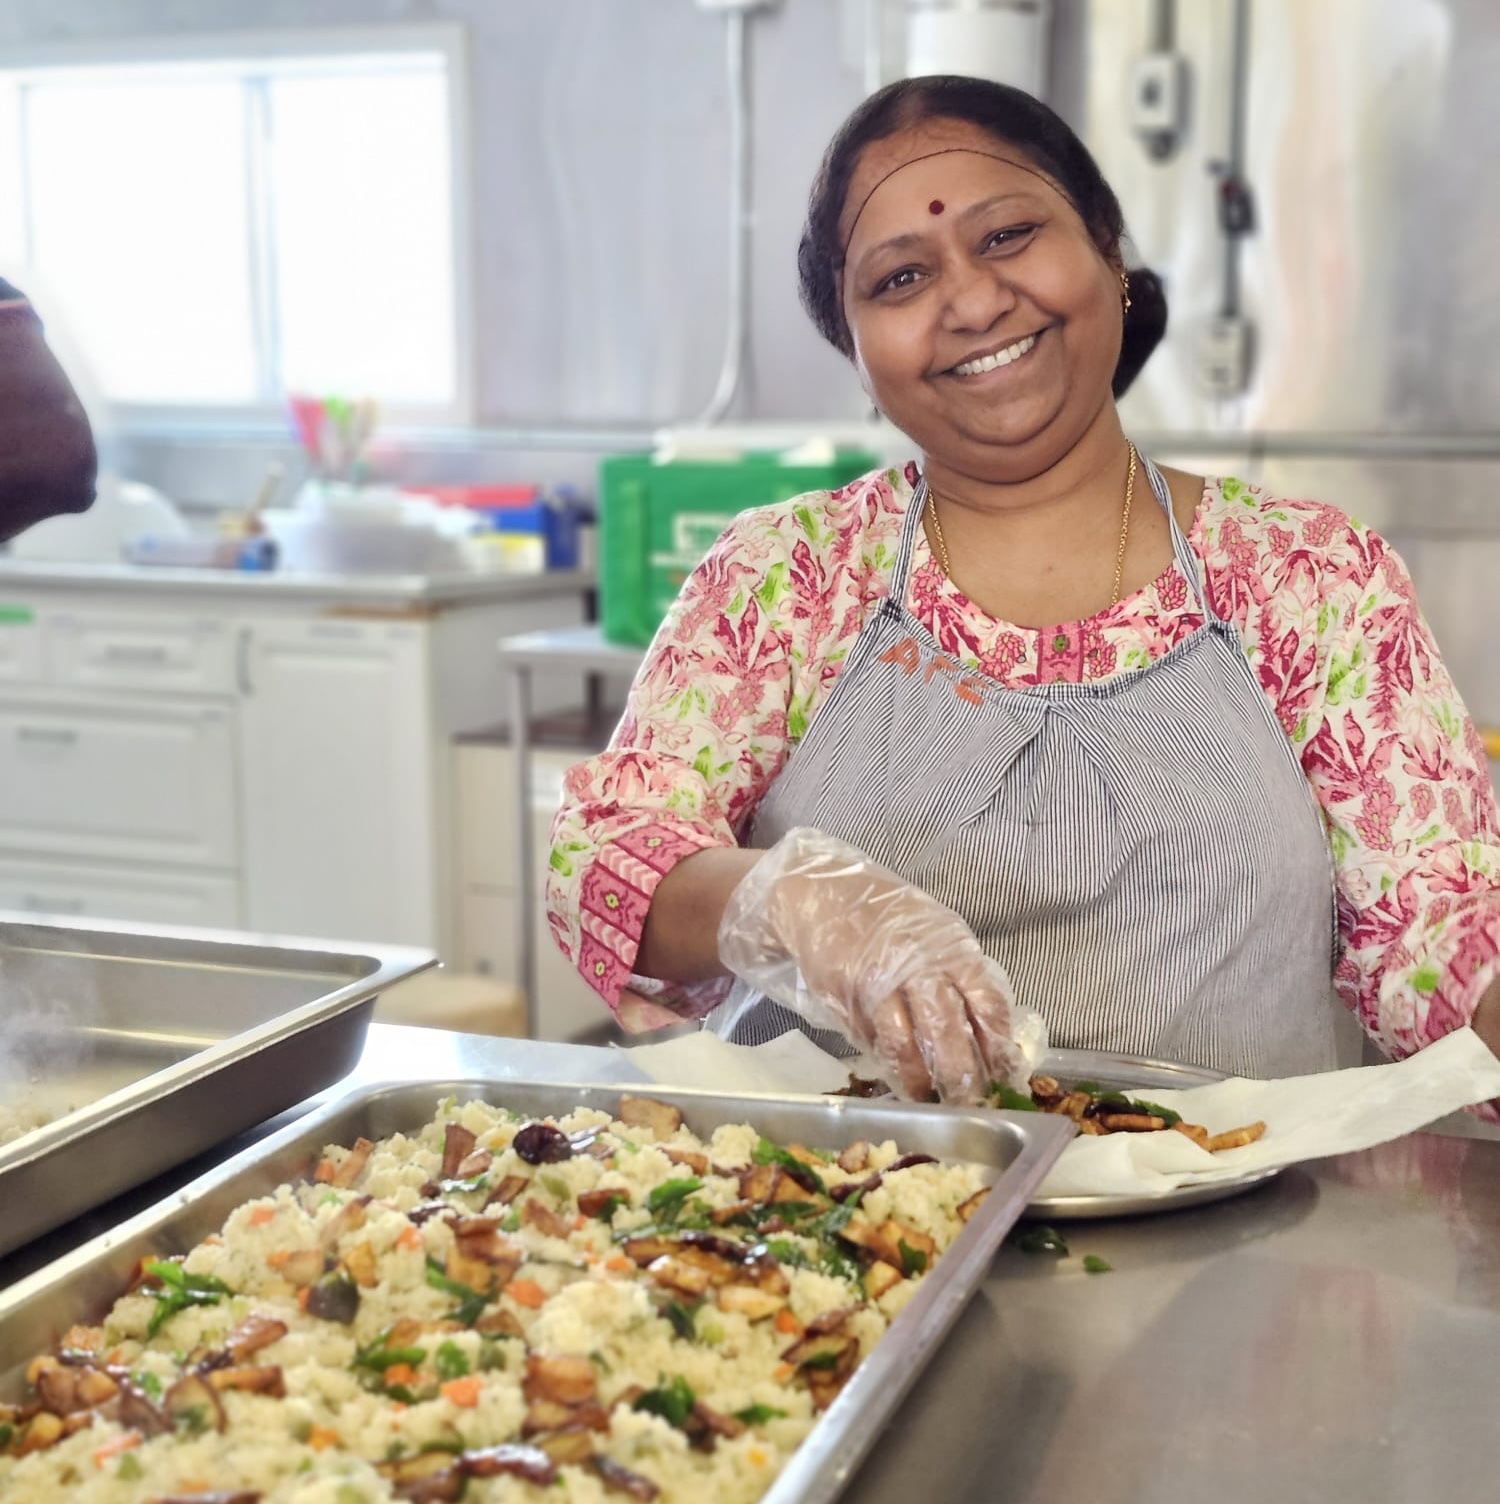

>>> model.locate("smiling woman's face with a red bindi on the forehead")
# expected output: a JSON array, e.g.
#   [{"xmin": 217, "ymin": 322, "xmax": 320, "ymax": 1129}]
[{"xmin": 840, "ymin": 119, "xmax": 1122, "ymax": 481}]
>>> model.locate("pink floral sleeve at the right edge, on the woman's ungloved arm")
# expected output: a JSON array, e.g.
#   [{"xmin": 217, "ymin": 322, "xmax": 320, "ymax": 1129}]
[{"xmin": 1280, "ymin": 523, "xmax": 1500, "ymax": 1057}]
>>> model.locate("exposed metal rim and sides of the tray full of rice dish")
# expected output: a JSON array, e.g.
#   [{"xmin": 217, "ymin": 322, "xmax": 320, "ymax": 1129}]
[{"xmin": 0, "ymin": 1081, "xmax": 1073, "ymax": 1504}]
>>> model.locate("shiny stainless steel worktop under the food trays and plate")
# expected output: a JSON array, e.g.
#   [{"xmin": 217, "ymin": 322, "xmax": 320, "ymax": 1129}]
[{"xmin": 0, "ymin": 1026, "xmax": 1500, "ymax": 1504}]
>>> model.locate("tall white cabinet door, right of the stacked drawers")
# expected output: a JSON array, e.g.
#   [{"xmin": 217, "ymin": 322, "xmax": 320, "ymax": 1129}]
[{"xmin": 239, "ymin": 621, "xmax": 439, "ymax": 945}]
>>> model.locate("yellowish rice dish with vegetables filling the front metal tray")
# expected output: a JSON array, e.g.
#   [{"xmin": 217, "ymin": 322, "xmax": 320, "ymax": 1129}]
[{"xmin": 0, "ymin": 1096, "xmax": 987, "ymax": 1504}]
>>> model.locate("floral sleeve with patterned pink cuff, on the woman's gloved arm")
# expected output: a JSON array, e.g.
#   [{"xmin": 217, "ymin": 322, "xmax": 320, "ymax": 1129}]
[{"xmin": 546, "ymin": 511, "xmax": 794, "ymax": 1027}]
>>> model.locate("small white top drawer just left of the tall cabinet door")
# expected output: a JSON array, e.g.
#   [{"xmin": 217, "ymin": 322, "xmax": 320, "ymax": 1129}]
[{"xmin": 50, "ymin": 611, "xmax": 235, "ymax": 695}]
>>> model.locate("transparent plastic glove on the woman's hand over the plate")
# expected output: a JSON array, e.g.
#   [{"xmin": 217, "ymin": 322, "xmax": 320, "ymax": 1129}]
[{"xmin": 719, "ymin": 829, "xmax": 1025, "ymax": 1102}]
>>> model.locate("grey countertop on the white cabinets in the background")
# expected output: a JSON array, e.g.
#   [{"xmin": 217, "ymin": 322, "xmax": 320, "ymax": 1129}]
[{"xmin": 0, "ymin": 558, "xmax": 593, "ymax": 608}]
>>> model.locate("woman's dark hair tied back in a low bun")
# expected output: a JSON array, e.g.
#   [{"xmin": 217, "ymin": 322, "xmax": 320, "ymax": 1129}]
[{"xmin": 797, "ymin": 75, "xmax": 1166, "ymax": 397}]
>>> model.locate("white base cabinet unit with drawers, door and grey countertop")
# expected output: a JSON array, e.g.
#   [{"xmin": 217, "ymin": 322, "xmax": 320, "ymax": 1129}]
[{"xmin": 0, "ymin": 561, "xmax": 588, "ymax": 970}]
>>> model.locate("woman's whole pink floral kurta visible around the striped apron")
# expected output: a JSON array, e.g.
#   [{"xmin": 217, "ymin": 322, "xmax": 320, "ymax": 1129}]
[{"xmin": 548, "ymin": 466, "xmax": 1500, "ymax": 1056}]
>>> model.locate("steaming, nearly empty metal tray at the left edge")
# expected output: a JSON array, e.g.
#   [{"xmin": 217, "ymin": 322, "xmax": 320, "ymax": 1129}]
[{"xmin": 0, "ymin": 913, "xmax": 436, "ymax": 1254}]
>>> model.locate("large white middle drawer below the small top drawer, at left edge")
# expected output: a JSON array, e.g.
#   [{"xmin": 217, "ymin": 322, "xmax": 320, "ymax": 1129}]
[{"xmin": 0, "ymin": 696, "xmax": 239, "ymax": 868}]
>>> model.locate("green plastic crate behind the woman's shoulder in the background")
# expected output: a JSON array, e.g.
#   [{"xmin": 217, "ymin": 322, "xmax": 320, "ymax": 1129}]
[{"xmin": 599, "ymin": 450, "xmax": 879, "ymax": 645}]
